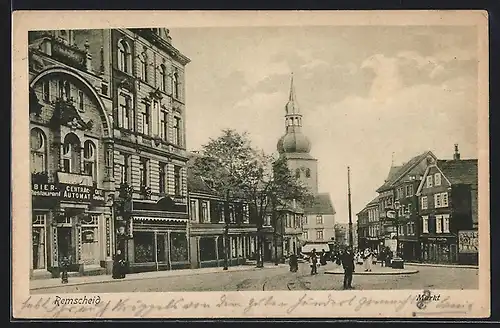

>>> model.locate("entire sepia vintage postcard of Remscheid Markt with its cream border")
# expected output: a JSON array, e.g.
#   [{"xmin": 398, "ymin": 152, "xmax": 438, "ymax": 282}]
[{"xmin": 12, "ymin": 11, "xmax": 490, "ymax": 319}]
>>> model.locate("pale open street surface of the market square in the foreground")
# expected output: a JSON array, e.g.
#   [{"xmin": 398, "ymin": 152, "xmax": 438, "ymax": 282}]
[{"xmin": 31, "ymin": 263, "xmax": 479, "ymax": 294}]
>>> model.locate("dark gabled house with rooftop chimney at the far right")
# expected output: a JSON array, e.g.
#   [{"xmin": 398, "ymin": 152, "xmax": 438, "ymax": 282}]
[{"xmin": 417, "ymin": 145, "xmax": 478, "ymax": 264}]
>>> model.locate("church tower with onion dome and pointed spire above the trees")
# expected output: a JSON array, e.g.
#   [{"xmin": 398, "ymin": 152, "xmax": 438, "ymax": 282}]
[{"xmin": 277, "ymin": 74, "xmax": 318, "ymax": 195}]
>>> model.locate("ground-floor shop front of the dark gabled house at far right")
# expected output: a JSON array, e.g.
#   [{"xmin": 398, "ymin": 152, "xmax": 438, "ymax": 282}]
[{"xmin": 420, "ymin": 235, "xmax": 458, "ymax": 264}]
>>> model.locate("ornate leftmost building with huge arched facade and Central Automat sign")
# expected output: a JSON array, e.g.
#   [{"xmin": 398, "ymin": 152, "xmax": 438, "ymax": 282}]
[{"xmin": 28, "ymin": 30, "xmax": 114, "ymax": 278}]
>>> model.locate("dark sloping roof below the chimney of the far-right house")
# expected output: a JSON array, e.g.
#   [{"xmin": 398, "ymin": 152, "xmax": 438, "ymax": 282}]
[{"xmin": 437, "ymin": 159, "xmax": 478, "ymax": 185}]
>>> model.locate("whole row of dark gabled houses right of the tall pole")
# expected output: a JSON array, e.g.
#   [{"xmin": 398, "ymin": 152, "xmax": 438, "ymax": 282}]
[{"xmin": 357, "ymin": 145, "xmax": 478, "ymax": 264}]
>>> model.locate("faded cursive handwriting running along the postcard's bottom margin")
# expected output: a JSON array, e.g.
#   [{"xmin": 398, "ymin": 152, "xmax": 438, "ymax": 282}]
[{"xmin": 21, "ymin": 292, "xmax": 472, "ymax": 318}]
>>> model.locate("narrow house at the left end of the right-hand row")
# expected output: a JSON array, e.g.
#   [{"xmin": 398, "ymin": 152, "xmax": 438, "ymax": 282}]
[{"xmin": 357, "ymin": 197, "xmax": 383, "ymax": 251}]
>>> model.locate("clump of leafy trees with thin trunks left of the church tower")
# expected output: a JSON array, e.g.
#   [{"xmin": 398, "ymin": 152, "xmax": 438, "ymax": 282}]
[{"xmin": 193, "ymin": 129, "xmax": 310, "ymax": 269}]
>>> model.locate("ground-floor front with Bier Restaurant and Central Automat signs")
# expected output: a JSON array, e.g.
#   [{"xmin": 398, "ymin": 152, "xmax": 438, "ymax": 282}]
[{"xmin": 30, "ymin": 179, "xmax": 112, "ymax": 278}]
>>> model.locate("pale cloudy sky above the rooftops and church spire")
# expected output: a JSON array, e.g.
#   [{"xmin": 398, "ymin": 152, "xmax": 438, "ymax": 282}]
[{"xmin": 170, "ymin": 26, "xmax": 478, "ymax": 222}]
